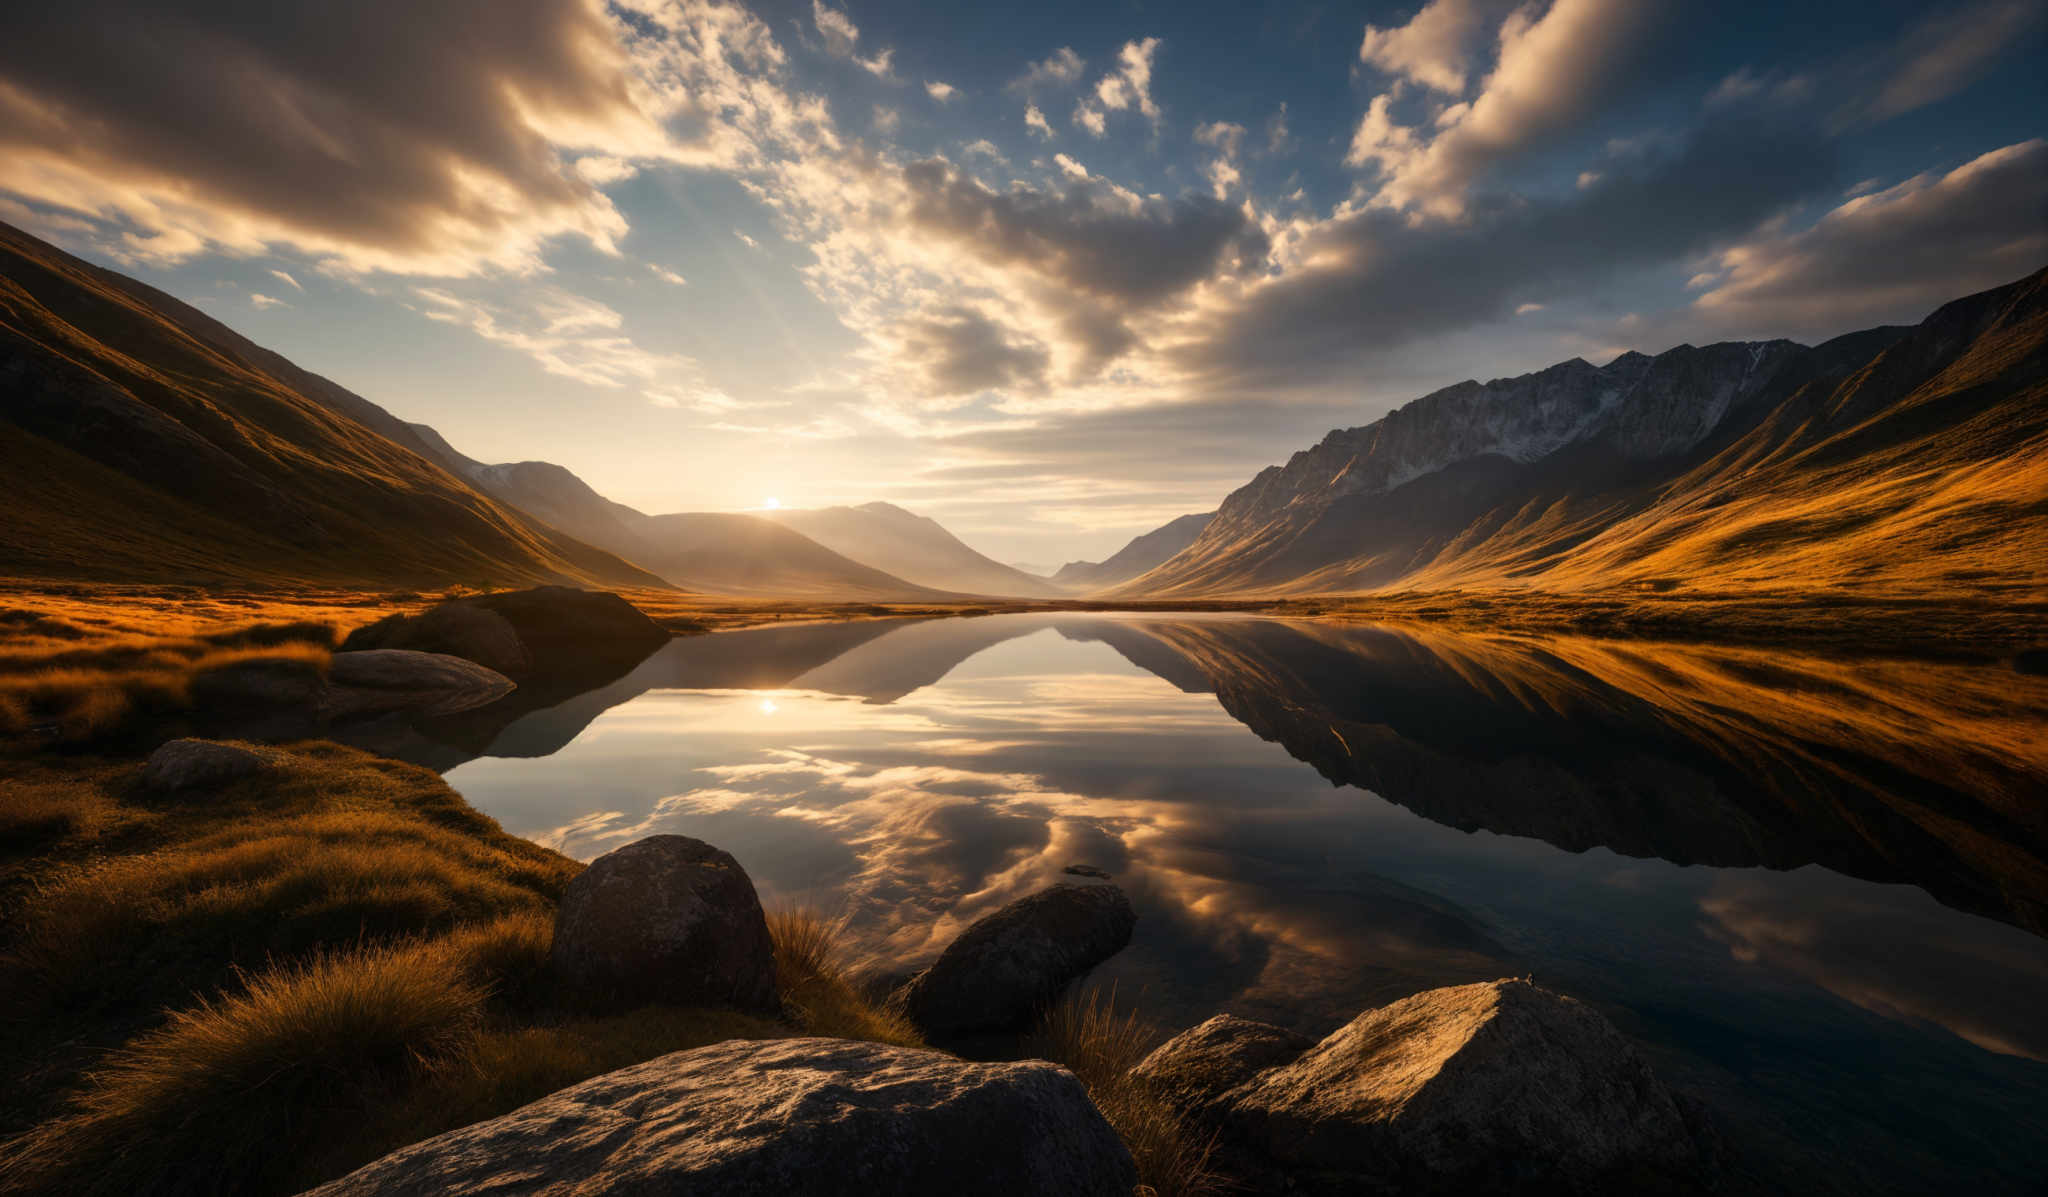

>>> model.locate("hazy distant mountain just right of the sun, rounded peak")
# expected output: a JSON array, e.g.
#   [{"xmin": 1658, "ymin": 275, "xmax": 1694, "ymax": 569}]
[{"xmin": 762, "ymin": 502, "xmax": 1063, "ymax": 599}]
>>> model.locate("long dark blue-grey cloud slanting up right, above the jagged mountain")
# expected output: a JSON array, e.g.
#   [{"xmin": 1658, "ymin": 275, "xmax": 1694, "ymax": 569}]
[{"xmin": 1176, "ymin": 121, "xmax": 1837, "ymax": 389}]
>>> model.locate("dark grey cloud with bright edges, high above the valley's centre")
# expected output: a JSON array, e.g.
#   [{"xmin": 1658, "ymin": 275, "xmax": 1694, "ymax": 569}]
[{"xmin": 903, "ymin": 160, "xmax": 1268, "ymax": 305}]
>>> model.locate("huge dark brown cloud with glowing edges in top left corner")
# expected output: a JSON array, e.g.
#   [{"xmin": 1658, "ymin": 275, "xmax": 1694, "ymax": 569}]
[{"xmin": 0, "ymin": 0, "xmax": 682, "ymax": 277}]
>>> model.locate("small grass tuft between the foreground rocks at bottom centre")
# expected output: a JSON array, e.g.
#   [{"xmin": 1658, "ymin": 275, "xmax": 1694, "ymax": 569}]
[{"xmin": 1032, "ymin": 988, "xmax": 1229, "ymax": 1197}]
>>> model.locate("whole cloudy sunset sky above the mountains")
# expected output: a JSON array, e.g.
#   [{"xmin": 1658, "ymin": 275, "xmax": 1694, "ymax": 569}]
[{"xmin": 0, "ymin": 0, "xmax": 2048, "ymax": 566}]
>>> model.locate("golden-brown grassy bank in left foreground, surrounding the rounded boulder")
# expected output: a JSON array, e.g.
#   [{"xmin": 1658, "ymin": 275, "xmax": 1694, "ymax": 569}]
[{"xmin": 0, "ymin": 744, "xmax": 920, "ymax": 1197}]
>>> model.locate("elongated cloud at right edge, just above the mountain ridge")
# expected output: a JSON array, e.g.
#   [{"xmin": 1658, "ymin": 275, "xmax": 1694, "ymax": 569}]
[{"xmin": 1694, "ymin": 139, "xmax": 2048, "ymax": 336}]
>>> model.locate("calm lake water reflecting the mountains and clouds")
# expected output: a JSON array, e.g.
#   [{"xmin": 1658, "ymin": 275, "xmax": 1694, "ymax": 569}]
[{"xmin": 412, "ymin": 615, "xmax": 2048, "ymax": 1193}]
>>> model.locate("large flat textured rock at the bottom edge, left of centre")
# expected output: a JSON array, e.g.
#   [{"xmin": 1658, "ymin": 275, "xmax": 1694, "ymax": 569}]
[{"xmin": 305, "ymin": 1039, "xmax": 1137, "ymax": 1197}]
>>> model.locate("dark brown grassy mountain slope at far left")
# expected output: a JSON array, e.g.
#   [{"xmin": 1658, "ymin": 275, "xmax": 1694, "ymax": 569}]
[{"xmin": 0, "ymin": 223, "xmax": 664, "ymax": 586}]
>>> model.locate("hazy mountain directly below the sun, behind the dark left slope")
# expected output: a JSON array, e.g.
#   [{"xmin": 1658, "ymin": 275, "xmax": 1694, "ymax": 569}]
[{"xmin": 408, "ymin": 424, "xmax": 979, "ymax": 603}]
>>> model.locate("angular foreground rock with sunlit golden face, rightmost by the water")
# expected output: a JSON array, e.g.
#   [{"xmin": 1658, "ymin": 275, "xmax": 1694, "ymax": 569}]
[{"xmin": 1190, "ymin": 980, "xmax": 1702, "ymax": 1195}]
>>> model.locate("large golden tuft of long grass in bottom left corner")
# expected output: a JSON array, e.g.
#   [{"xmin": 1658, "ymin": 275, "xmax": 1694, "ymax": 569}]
[{"xmin": 0, "ymin": 945, "xmax": 485, "ymax": 1197}]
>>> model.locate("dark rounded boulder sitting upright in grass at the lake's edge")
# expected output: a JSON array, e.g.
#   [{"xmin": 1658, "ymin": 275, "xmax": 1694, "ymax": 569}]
[{"xmin": 553, "ymin": 836, "xmax": 776, "ymax": 1010}]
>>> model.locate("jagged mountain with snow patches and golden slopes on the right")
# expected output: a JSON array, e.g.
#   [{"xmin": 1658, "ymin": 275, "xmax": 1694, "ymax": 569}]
[{"xmin": 1116, "ymin": 271, "xmax": 2048, "ymax": 599}]
